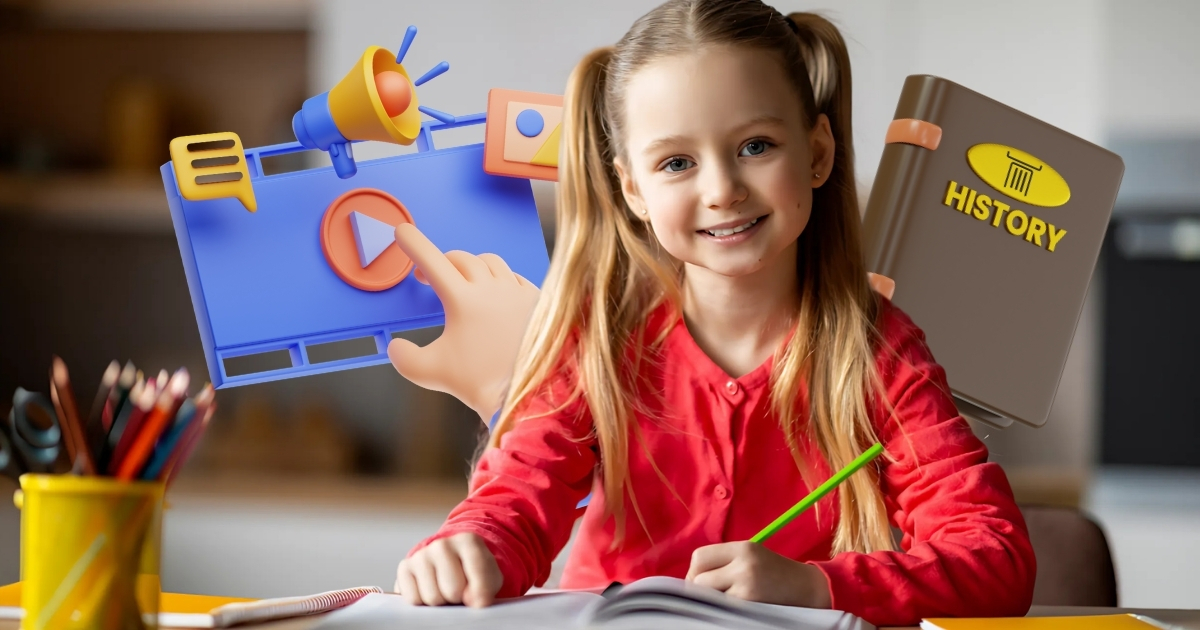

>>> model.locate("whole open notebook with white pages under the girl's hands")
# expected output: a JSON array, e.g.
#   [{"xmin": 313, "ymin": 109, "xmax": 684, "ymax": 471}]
[{"xmin": 317, "ymin": 577, "xmax": 875, "ymax": 630}]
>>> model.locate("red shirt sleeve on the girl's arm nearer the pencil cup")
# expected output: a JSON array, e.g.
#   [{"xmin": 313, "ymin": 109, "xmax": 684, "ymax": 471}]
[{"xmin": 408, "ymin": 374, "xmax": 598, "ymax": 598}]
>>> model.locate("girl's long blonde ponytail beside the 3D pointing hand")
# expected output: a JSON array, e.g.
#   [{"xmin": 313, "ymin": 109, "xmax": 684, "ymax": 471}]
[{"xmin": 488, "ymin": 47, "xmax": 678, "ymax": 546}]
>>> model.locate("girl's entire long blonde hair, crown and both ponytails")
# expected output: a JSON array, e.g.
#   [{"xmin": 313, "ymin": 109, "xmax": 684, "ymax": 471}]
[{"xmin": 487, "ymin": 0, "xmax": 893, "ymax": 553}]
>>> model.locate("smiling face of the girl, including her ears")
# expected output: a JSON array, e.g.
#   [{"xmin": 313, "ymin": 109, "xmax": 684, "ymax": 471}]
[{"xmin": 616, "ymin": 46, "xmax": 834, "ymax": 277}]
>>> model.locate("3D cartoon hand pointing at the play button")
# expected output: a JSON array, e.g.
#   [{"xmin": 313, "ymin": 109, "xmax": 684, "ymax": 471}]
[{"xmin": 388, "ymin": 223, "xmax": 540, "ymax": 425}]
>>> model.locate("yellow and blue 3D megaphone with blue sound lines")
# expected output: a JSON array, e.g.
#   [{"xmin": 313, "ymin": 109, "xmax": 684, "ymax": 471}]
[{"xmin": 292, "ymin": 26, "xmax": 454, "ymax": 179}]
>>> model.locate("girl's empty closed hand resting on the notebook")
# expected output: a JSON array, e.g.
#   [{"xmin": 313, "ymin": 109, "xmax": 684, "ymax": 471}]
[{"xmin": 395, "ymin": 533, "xmax": 504, "ymax": 608}]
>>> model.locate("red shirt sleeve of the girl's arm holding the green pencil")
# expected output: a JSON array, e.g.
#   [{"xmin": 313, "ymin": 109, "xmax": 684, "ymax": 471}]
[{"xmin": 812, "ymin": 300, "xmax": 1037, "ymax": 625}]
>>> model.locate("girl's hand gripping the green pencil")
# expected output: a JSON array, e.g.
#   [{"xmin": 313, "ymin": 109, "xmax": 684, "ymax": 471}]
[{"xmin": 686, "ymin": 541, "xmax": 830, "ymax": 608}]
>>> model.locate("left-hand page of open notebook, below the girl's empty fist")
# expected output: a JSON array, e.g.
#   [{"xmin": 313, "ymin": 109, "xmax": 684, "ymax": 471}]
[{"xmin": 313, "ymin": 593, "xmax": 600, "ymax": 630}]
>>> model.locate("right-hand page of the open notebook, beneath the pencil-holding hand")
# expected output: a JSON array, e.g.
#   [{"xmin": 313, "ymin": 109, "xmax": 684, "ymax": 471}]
[{"xmin": 581, "ymin": 577, "xmax": 874, "ymax": 630}]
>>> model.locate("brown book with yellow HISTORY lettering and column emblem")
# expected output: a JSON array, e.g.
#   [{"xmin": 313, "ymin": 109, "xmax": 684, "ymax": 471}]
[{"xmin": 863, "ymin": 74, "xmax": 1124, "ymax": 426}]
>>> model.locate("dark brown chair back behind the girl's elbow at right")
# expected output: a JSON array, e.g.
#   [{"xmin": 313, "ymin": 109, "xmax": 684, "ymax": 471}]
[{"xmin": 1021, "ymin": 505, "xmax": 1117, "ymax": 607}]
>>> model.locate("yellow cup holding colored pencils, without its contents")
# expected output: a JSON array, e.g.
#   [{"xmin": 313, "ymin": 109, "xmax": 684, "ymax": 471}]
[{"xmin": 13, "ymin": 474, "xmax": 163, "ymax": 630}]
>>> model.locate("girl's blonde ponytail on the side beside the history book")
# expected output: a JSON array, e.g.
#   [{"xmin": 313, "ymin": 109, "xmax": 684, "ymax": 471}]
[{"xmin": 776, "ymin": 13, "xmax": 894, "ymax": 553}]
